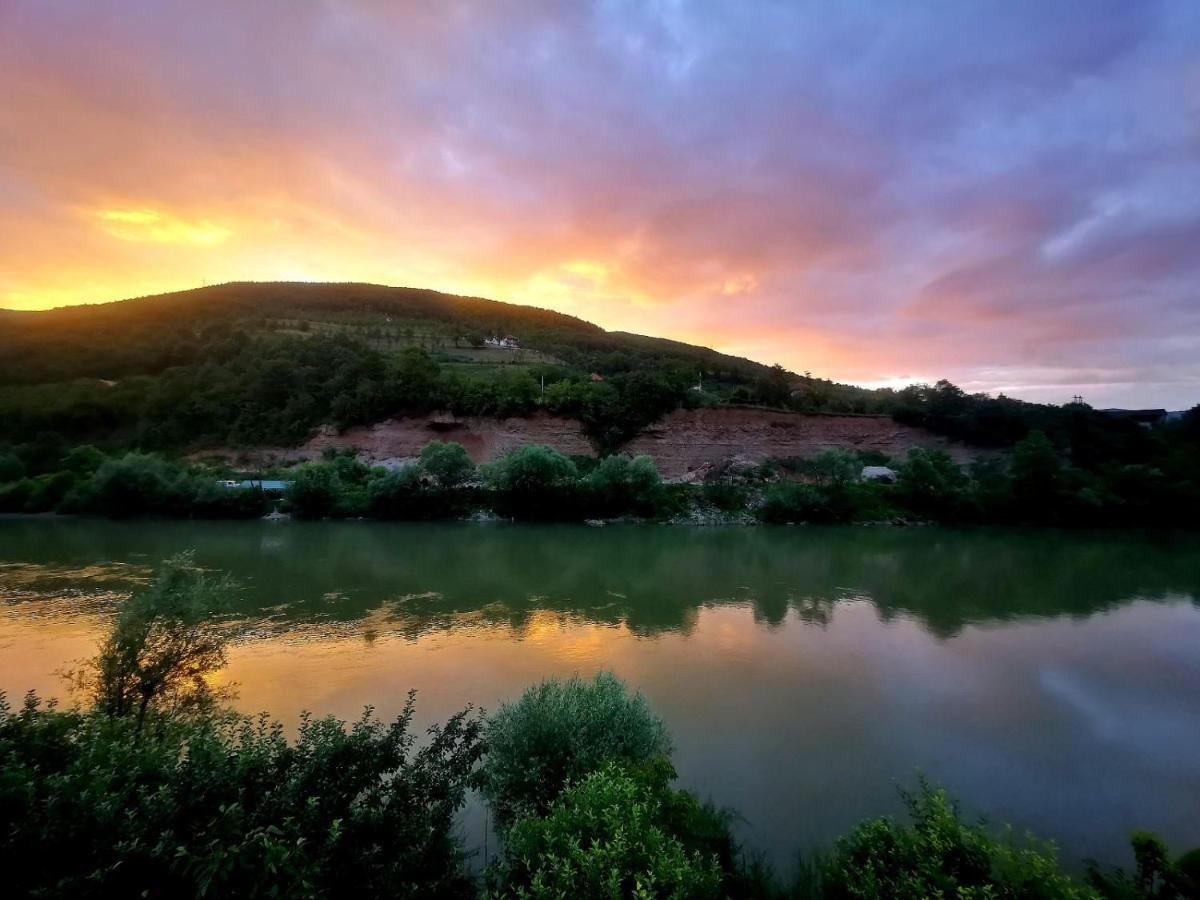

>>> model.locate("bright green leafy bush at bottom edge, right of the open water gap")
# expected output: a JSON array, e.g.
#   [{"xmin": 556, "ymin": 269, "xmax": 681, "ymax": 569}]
[{"xmin": 821, "ymin": 781, "xmax": 1094, "ymax": 900}]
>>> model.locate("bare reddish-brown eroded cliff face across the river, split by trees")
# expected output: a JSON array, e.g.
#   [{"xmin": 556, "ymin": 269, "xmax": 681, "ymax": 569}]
[{"xmin": 211, "ymin": 408, "xmax": 980, "ymax": 480}]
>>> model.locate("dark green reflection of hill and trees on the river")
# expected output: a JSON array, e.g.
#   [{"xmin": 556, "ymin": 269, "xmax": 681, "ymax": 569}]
[{"xmin": 0, "ymin": 521, "xmax": 1200, "ymax": 638}]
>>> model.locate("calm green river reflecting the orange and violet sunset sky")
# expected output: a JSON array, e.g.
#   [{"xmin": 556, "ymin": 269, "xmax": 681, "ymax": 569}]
[{"xmin": 0, "ymin": 520, "xmax": 1200, "ymax": 866}]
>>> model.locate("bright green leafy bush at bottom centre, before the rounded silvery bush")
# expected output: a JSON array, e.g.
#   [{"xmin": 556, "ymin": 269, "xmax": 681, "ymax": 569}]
[{"xmin": 491, "ymin": 762, "xmax": 722, "ymax": 900}]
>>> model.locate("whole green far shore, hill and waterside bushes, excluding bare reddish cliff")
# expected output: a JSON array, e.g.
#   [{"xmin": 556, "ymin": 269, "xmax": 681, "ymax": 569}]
[{"xmin": 0, "ymin": 283, "xmax": 1200, "ymax": 526}]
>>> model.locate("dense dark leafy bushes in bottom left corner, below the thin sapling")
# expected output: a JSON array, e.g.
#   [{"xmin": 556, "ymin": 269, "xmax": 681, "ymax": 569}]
[{"xmin": 0, "ymin": 697, "xmax": 481, "ymax": 898}]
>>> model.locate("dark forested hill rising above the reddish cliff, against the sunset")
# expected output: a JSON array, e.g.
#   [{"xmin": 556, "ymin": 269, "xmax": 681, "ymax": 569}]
[{"xmin": 0, "ymin": 283, "xmax": 883, "ymax": 450}]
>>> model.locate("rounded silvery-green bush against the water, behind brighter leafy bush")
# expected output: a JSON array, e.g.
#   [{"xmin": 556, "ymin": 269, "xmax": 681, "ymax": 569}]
[{"xmin": 482, "ymin": 672, "xmax": 671, "ymax": 827}]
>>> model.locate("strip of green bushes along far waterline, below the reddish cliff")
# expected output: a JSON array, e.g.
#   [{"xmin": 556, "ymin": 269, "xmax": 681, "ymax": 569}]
[{"xmin": 0, "ymin": 409, "xmax": 1200, "ymax": 528}]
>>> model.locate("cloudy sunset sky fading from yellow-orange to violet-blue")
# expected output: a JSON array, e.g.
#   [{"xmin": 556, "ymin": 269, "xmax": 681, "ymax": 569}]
[{"xmin": 0, "ymin": 0, "xmax": 1200, "ymax": 409}]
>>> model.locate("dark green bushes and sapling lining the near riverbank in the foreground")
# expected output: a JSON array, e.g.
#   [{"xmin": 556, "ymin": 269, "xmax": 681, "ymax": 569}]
[{"xmin": 0, "ymin": 556, "xmax": 1200, "ymax": 900}]
